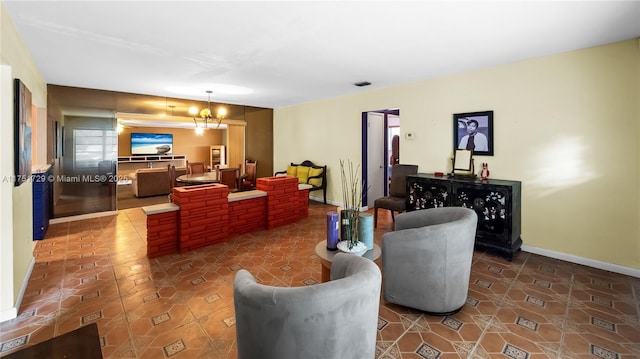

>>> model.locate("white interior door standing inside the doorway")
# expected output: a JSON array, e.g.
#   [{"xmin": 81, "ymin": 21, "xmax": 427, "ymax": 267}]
[{"xmin": 366, "ymin": 112, "xmax": 386, "ymax": 208}]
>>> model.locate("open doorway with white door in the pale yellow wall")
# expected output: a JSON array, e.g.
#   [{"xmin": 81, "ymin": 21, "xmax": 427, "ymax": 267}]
[{"xmin": 362, "ymin": 109, "xmax": 400, "ymax": 208}]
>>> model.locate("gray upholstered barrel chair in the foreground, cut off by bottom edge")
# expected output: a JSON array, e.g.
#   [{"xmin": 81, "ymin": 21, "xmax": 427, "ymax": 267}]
[{"xmin": 238, "ymin": 253, "xmax": 381, "ymax": 359}]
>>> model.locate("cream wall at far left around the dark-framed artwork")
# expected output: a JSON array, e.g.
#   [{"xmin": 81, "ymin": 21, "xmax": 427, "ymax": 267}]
[{"xmin": 0, "ymin": 3, "xmax": 47, "ymax": 321}]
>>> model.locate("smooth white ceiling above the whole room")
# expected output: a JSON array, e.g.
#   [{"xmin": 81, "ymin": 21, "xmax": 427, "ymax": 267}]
[{"xmin": 2, "ymin": 0, "xmax": 640, "ymax": 108}]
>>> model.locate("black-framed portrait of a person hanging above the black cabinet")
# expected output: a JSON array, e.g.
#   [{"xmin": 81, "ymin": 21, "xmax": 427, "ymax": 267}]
[{"xmin": 453, "ymin": 111, "xmax": 493, "ymax": 156}]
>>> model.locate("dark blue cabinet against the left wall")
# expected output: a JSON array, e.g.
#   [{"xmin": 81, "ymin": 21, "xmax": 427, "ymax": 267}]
[{"xmin": 31, "ymin": 166, "xmax": 53, "ymax": 240}]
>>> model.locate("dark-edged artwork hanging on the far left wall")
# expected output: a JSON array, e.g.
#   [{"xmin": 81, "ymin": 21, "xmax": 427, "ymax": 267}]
[{"xmin": 13, "ymin": 79, "xmax": 31, "ymax": 186}]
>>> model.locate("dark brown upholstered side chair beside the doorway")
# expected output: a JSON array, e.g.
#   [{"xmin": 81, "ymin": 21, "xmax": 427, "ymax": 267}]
[{"xmin": 373, "ymin": 165, "xmax": 418, "ymax": 228}]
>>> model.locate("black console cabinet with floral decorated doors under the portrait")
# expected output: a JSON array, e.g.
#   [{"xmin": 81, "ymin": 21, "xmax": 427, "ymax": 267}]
[{"xmin": 407, "ymin": 173, "xmax": 522, "ymax": 261}]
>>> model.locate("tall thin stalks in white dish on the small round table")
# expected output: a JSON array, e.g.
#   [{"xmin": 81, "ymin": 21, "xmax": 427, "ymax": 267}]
[{"xmin": 339, "ymin": 160, "xmax": 366, "ymax": 252}]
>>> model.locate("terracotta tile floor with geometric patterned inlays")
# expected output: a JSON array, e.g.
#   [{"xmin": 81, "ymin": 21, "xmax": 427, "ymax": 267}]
[{"xmin": 0, "ymin": 202, "xmax": 640, "ymax": 359}]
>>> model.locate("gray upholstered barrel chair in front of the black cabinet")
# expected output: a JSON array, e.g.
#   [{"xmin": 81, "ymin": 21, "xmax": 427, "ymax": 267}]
[{"xmin": 382, "ymin": 207, "xmax": 478, "ymax": 315}]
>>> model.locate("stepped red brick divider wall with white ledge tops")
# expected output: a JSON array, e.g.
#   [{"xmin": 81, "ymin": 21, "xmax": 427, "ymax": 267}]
[{"xmin": 143, "ymin": 177, "xmax": 309, "ymax": 258}]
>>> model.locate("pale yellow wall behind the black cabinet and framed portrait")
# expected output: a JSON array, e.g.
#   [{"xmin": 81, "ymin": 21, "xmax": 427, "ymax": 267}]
[{"xmin": 274, "ymin": 39, "xmax": 640, "ymax": 269}]
